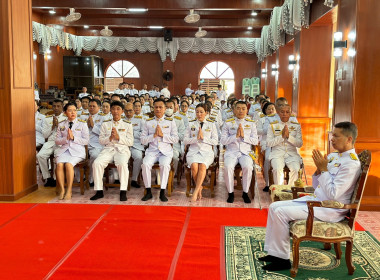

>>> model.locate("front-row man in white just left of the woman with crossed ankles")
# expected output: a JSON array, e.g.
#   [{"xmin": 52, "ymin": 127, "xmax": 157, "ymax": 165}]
[{"xmin": 141, "ymin": 99, "xmax": 178, "ymax": 202}]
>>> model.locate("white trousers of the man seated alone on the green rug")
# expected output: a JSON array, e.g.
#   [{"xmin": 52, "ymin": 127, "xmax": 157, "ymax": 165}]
[{"xmin": 264, "ymin": 200, "xmax": 307, "ymax": 259}]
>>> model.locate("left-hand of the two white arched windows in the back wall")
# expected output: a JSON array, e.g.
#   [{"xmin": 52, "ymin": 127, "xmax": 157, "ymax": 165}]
[{"xmin": 105, "ymin": 60, "xmax": 140, "ymax": 92}]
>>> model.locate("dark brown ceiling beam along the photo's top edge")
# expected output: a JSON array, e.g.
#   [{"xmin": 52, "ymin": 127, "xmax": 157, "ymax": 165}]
[{"xmin": 32, "ymin": 0, "xmax": 283, "ymax": 10}]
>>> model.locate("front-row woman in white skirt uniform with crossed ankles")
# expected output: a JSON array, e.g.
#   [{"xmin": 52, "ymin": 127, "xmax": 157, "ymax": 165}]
[{"xmin": 184, "ymin": 104, "xmax": 219, "ymax": 202}]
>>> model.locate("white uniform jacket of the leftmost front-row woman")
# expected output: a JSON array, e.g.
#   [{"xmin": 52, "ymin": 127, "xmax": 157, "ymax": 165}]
[{"xmin": 55, "ymin": 119, "xmax": 90, "ymax": 159}]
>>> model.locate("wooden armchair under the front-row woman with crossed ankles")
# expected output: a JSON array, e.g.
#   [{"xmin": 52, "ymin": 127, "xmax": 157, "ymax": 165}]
[{"xmin": 183, "ymin": 145, "xmax": 219, "ymax": 197}]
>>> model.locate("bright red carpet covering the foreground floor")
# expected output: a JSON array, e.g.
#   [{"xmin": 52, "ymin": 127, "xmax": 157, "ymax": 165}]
[{"xmin": 0, "ymin": 204, "xmax": 363, "ymax": 280}]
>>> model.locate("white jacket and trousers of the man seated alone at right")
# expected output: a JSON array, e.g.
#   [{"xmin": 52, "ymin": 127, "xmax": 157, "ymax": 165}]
[{"xmin": 264, "ymin": 149, "xmax": 361, "ymax": 259}]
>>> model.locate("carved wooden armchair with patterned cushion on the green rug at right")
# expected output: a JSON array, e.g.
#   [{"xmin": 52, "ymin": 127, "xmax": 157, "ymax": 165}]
[{"xmin": 290, "ymin": 150, "xmax": 371, "ymax": 277}]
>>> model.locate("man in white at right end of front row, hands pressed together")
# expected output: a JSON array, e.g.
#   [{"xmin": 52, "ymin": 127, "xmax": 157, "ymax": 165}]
[{"xmin": 267, "ymin": 104, "xmax": 303, "ymax": 186}]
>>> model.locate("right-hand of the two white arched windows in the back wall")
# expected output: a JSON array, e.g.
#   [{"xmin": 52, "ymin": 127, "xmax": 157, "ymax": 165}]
[{"xmin": 199, "ymin": 61, "xmax": 235, "ymax": 94}]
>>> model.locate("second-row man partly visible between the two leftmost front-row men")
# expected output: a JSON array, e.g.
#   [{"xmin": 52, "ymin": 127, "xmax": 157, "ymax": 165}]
[{"xmin": 124, "ymin": 101, "xmax": 145, "ymax": 188}]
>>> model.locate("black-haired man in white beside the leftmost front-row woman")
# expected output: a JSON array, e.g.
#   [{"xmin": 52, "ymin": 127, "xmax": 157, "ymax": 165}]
[{"xmin": 90, "ymin": 101, "xmax": 133, "ymax": 201}]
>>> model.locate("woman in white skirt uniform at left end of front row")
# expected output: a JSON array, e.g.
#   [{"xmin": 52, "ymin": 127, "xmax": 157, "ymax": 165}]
[{"xmin": 55, "ymin": 103, "xmax": 90, "ymax": 200}]
